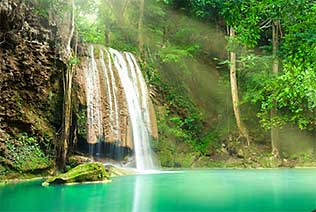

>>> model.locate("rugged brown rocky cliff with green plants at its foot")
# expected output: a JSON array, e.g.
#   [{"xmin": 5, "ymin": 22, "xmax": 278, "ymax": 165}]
[{"xmin": 0, "ymin": 0, "xmax": 66, "ymax": 176}]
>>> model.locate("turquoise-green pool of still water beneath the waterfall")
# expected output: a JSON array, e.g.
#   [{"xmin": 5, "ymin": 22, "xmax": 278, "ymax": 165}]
[{"xmin": 0, "ymin": 169, "xmax": 316, "ymax": 212}]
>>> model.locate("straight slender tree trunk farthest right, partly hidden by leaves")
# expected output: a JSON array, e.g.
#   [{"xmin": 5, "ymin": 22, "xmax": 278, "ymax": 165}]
[{"xmin": 271, "ymin": 21, "xmax": 280, "ymax": 158}]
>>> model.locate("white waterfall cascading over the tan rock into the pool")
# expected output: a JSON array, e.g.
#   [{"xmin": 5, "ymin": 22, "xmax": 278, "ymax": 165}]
[{"xmin": 85, "ymin": 45, "xmax": 155, "ymax": 171}]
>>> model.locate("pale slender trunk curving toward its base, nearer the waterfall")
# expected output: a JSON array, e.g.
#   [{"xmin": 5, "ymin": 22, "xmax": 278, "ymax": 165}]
[{"xmin": 229, "ymin": 27, "xmax": 250, "ymax": 145}]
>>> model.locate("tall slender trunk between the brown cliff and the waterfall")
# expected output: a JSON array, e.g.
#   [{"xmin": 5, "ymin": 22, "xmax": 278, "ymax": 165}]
[{"xmin": 57, "ymin": 0, "xmax": 75, "ymax": 170}]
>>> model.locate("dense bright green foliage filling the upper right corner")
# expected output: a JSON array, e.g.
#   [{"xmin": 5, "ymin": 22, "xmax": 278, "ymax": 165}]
[{"xmin": 165, "ymin": 0, "xmax": 316, "ymax": 128}]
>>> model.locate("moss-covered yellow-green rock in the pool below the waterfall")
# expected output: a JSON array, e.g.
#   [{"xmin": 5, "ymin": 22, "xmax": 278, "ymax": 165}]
[{"xmin": 42, "ymin": 162, "xmax": 110, "ymax": 186}]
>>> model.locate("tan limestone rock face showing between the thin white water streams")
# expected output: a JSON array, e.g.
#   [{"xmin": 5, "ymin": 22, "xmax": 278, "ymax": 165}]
[{"xmin": 74, "ymin": 46, "xmax": 133, "ymax": 149}]
